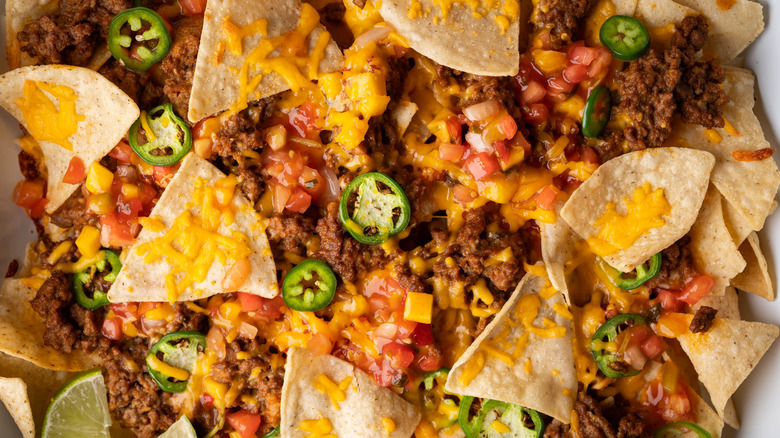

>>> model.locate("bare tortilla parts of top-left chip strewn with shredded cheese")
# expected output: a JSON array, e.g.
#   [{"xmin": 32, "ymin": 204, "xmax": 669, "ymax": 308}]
[{"xmin": 187, "ymin": 0, "xmax": 341, "ymax": 122}]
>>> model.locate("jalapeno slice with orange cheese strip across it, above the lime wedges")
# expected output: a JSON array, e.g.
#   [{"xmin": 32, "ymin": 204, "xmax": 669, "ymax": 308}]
[{"xmin": 146, "ymin": 331, "xmax": 206, "ymax": 392}]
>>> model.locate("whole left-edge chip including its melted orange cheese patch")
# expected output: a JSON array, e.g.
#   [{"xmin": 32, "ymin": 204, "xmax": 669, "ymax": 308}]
[{"xmin": 0, "ymin": 65, "xmax": 140, "ymax": 213}]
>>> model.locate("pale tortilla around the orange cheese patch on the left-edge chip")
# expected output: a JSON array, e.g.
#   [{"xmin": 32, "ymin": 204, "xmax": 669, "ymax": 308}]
[{"xmin": 0, "ymin": 65, "xmax": 139, "ymax": 213}]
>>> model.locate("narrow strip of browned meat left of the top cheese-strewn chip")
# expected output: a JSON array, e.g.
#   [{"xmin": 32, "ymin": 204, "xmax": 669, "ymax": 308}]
[{"xmin": 160, "ymin": 15, "xmax": 203, "ymax": 120}]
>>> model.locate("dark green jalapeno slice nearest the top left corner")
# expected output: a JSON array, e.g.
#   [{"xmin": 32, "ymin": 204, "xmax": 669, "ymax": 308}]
[{"xmin": 108, "ymin": 7, "xmax": 171, "ymax": 71}]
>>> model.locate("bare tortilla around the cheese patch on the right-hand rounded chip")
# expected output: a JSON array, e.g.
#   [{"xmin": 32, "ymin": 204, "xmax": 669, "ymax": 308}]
[{"xmin": 561, "ymin": 148, "xmax": 715, "ymax": 272}]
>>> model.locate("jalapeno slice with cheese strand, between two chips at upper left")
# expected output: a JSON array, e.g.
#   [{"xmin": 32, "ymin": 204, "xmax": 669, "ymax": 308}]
[{"xmin": 128, "ymin": 103, "xmax": 192, "ymax": 167}]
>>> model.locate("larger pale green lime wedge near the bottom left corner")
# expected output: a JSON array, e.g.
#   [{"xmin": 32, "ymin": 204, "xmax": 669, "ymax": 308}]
[{"xmin": 41, "ymin": 369, "xmax": 111, "ymax": 438}]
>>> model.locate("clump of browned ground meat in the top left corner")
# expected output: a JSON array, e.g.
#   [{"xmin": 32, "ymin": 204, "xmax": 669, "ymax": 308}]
[{"xmin": 17, "ymin": 0, "xmax": 133, "ymax": 66}]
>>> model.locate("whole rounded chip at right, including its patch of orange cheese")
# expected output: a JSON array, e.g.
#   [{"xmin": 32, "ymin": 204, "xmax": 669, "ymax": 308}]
[{"xmin": 561, "ymin": 148, "xmax": 715, "ymax": 272}]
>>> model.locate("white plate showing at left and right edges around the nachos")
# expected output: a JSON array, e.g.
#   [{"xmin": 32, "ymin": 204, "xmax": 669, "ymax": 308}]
[{"xmin": 0, "ymin": 0, "xmax": 780, "ymax": 438}]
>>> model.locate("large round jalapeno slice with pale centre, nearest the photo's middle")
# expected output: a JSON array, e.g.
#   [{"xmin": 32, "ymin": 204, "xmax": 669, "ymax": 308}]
[{"xmin": 339, "ymin": 172, "xmax": 411, "ymax": 245}]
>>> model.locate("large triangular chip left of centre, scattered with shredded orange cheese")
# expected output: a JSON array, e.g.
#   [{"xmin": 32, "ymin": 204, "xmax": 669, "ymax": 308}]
[{"xmin": 108, "ymin": 153, "xmax": 279, "ymax": 303}]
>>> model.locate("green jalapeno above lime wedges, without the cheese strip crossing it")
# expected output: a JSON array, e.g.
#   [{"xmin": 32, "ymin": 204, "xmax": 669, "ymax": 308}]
[{"xmin": 146, "ymin": 331, "xmax": 206, "ymax": 393}]
